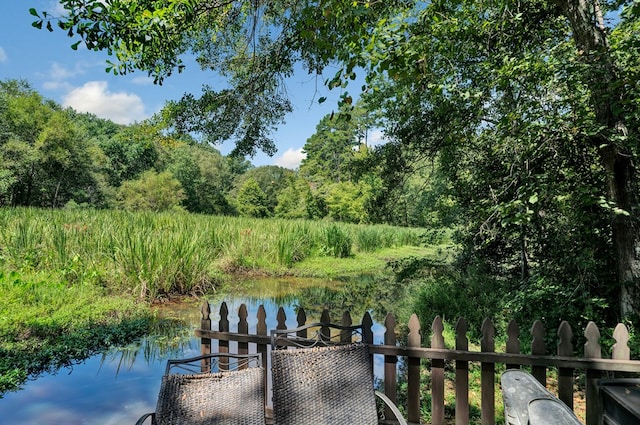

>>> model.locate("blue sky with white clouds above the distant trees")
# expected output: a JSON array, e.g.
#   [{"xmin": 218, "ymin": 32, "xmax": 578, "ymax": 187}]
[{"xmin": 0, "ymin": 0, "xmax": 370, "ymax": 168}]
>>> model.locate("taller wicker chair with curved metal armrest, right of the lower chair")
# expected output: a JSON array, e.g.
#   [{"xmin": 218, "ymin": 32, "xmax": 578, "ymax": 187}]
[{"xmin": 271, "ymin": 323, "xmax": 406, "ymax": 425}]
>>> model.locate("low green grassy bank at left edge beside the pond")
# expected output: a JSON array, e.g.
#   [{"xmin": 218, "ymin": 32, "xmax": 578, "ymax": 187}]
[{"xmin": 0, "ymin": 272, "xmax": 165, "ymax": 397}]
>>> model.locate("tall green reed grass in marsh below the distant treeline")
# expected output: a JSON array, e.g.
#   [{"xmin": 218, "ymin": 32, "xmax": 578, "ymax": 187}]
[{"xmin": 0, "ymin": 208, "xmax": 425, "ymax": 299}]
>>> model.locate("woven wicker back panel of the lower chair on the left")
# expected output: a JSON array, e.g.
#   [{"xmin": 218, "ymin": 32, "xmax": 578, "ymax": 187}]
[{"xmin": 156, "ymin": 368, "xmax": 265, "ymax": 425}]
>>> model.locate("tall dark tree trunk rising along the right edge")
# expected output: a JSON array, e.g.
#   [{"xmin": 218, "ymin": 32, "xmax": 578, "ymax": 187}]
[{"xmin": 557, "ymin": 0, "xmax": 640, "ymax": 317}]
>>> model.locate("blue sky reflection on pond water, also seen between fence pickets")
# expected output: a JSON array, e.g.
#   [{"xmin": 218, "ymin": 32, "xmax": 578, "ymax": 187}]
[{"xmin": 0, "ymin": 284, "xmax": 392, "ymax": 425}]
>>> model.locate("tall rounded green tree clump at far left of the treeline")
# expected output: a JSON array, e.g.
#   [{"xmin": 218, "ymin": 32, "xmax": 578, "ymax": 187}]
[{"xmin": 0, "ymin": 80, "xmax": 100, "ymax": 207}]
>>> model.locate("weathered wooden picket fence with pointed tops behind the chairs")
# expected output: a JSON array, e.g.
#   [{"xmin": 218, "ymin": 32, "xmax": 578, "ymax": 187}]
[{"xmin": 195, "ymin": 302, "xmax": 640, "ymax": 425}]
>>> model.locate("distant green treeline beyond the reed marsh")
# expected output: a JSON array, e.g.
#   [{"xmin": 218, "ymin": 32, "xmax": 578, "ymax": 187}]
[{"xmin": 0, "ymin": 80, "xmax": 440, "ymax": 226}]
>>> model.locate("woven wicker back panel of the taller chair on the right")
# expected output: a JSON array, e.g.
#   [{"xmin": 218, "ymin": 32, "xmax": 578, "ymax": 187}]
[{"xmin": 271, "ymin": 344, "xmax": 378, "ymax": 425}]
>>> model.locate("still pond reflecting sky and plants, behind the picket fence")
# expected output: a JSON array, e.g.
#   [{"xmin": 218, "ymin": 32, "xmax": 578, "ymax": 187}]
[{"xmin": 0, "ymin": 277, "xmax": 405, "ymax": 425}]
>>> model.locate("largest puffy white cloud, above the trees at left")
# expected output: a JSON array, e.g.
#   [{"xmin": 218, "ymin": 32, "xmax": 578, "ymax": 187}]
[{"xmin": 62, "ymin": 81, "xmax": 148, "ymax": 124}]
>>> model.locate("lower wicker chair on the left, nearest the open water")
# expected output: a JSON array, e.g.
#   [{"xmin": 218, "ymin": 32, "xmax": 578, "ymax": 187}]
[{"xmin": 136, "ymin": 353, "xmax": 265, "ymax": 425}]
